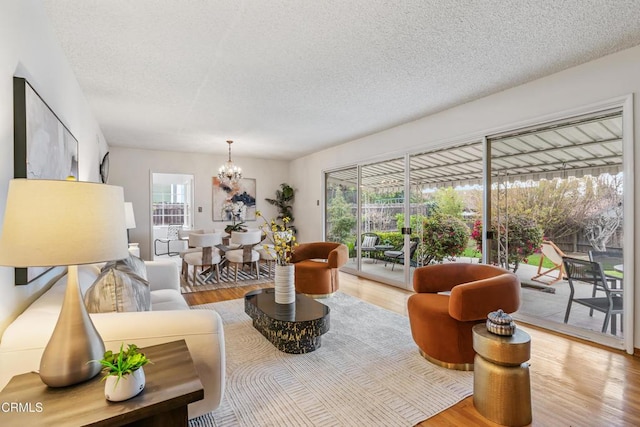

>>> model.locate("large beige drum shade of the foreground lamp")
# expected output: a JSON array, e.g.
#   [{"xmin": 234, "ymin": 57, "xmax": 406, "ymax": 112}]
[{"xmin": 0, "ymin": 179, "xmax": 128, "ymax": 267}]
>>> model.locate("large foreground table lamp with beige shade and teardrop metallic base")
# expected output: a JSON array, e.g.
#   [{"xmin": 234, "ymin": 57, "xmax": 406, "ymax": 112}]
[{"xmin": 0, "ymin": 179, "xmax": 129, "ymax": 387}]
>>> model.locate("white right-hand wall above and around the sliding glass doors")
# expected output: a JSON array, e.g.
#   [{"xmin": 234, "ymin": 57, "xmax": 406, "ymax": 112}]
[{"xmin": 291, "ymin": 46, "xmax": 640, "ymax": 347}]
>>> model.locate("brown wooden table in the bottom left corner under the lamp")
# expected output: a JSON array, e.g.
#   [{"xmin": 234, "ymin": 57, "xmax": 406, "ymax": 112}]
[{"xmin": 0, "ymin": 340, "xmax": 204, "ymax": 427}]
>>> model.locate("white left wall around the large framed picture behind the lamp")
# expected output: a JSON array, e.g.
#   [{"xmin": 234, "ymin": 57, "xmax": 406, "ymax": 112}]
[{"xmin": 0, "ymin": 0, "xmax": 107, "ymax": 333}]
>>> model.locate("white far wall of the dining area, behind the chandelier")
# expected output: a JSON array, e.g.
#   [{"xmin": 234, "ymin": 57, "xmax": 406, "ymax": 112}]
[{"xmin": 109, "ymin": 147, "xmax": 288, "ymax": 259}]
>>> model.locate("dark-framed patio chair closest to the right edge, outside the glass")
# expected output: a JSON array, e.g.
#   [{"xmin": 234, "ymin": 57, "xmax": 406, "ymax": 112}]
[{"xmin": 562, "ymin": 257, "xmax": 623, "ymax": 335}]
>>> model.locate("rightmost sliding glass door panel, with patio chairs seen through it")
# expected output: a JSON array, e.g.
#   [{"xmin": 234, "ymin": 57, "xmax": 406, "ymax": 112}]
[{"xmin": 488, "ymin": 109, "xmax": 625, "ymax": 347}]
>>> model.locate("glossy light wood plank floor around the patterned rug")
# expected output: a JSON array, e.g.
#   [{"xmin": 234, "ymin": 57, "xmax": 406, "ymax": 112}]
[{"xmin": 184, "ymin": 273, "xmax": 640, "ymax": 427}]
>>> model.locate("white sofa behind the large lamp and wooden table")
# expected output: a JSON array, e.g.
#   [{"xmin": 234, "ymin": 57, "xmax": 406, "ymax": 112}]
[{"xmin": 0, "ymin": 260, "xmax": 225, "ymax": 418}]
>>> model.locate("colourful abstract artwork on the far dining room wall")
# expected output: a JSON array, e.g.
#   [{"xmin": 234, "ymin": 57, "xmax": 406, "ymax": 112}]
[{"xmin": 212, "ymin": 177, "xmax": 256, "ymax": 224}]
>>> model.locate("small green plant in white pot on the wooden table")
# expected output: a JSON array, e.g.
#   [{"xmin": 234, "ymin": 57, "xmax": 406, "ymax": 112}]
[{"xmin": 99, "ymin": 343, "xmax": 151, "ymax": 402}]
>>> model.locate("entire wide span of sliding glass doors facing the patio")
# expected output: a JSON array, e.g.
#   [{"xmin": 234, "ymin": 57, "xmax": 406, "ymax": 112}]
[{"xmin": 325, "ymin": 101, "xmax": 635, "ymax": 351}]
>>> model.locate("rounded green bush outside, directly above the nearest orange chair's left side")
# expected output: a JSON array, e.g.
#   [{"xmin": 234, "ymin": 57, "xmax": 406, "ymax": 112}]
[{"xmin": 418, "ymin": 215, "xmax": 469, "ymax": 265}]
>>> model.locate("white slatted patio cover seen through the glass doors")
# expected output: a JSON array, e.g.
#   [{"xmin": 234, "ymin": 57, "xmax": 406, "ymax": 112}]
[{"xmin": 331, "ymin": 110, "xmax": 623, "ymax": 190}]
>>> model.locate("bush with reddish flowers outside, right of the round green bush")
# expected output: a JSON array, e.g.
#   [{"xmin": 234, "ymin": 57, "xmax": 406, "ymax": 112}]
[{"xmin": 471, "ymin": 215, "xmax": 543, "ymax": 271}]
